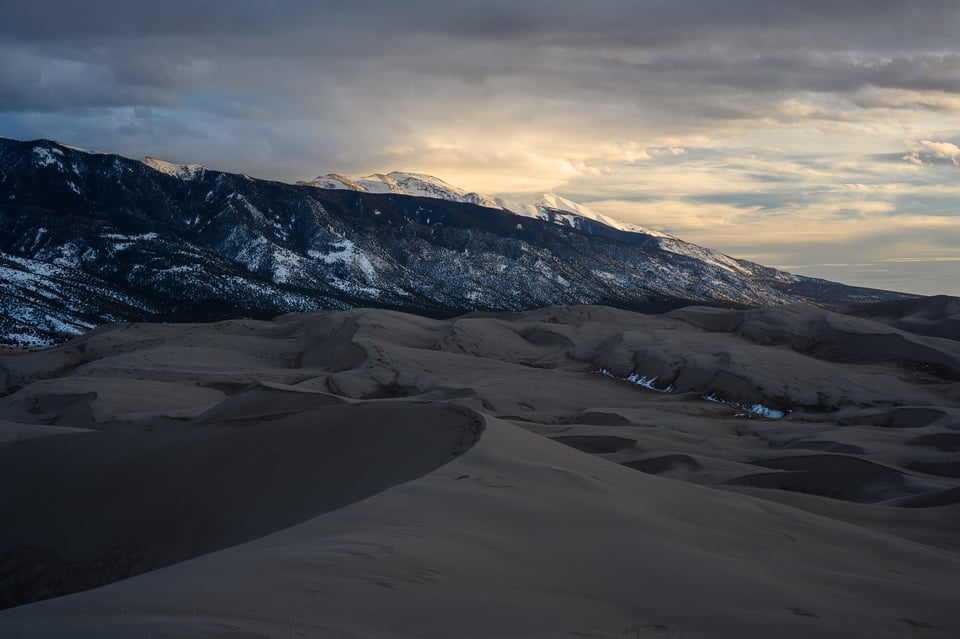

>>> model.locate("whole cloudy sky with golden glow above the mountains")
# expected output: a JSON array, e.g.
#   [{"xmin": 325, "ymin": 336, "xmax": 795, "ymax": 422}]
[{"xmin": 0, "ymin": 0, "xmax": 960, "ymax": 295}]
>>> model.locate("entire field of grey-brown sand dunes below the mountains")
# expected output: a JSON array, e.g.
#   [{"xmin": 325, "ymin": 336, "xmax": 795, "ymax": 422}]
[{"xmin": 0, "ymin": 298, "xmax": 960, "ymax": 639}]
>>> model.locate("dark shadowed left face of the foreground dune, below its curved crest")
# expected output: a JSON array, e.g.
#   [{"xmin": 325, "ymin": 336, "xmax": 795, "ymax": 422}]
[{"xmin": 0, "ymin": 400, "xmax": 480, "ymax": 607}]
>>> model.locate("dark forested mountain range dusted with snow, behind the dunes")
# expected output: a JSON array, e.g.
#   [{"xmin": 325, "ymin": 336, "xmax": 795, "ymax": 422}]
[{"xmin": 0, "ymin": 138, "xmax": 907, "ymax": 346}]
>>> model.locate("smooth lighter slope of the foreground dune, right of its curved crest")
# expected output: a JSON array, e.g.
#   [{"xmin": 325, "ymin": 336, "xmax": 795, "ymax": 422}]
[{"xmin": 0, "ymin": 420, "xmax": 960, "ymax": 639}]
